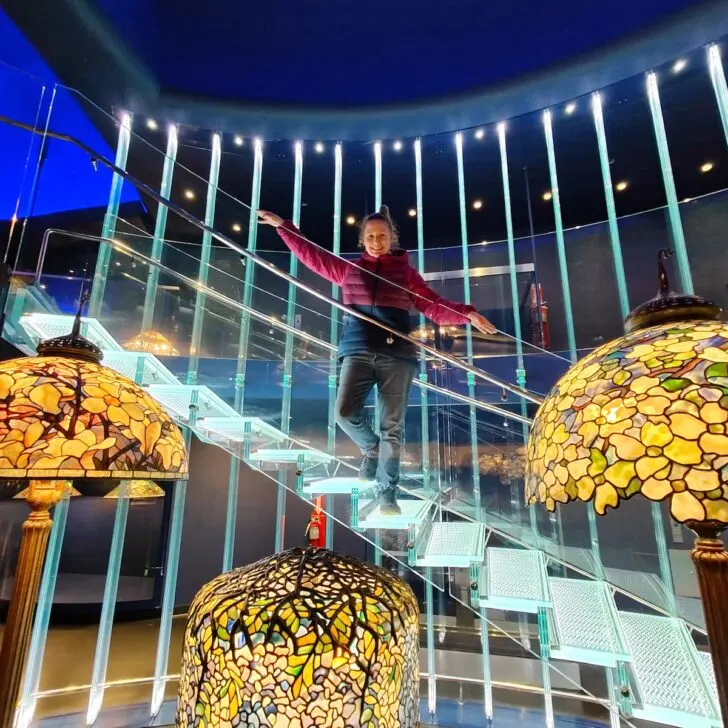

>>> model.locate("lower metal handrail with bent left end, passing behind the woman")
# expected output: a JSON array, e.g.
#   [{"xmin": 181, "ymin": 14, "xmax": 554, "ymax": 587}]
[{"xmin": 34, "ymin": 228, "xmax": 531, "ymax": 425}]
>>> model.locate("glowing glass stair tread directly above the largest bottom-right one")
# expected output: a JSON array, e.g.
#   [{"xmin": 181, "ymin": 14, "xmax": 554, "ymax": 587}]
[{"xmin": 548, "ymin": 577, "xmax": 631, "ymax": 667}]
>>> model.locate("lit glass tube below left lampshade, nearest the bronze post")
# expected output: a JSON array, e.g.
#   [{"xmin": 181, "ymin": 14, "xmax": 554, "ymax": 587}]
[{"xmin": 15, "ymin": 489, "xmax": 71, "ymax": 728}]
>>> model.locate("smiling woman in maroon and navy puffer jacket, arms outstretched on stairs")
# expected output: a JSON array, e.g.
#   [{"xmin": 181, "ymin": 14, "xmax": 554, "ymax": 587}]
[{"xmin": 258, "ymin": 206, "xmax": 496, "ymax": 515}]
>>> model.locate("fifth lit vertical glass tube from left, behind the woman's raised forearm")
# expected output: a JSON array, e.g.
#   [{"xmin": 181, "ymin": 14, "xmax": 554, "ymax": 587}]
[{"xmin": 274, "ymin": 141, "xmax": 303, "ymax": 553}]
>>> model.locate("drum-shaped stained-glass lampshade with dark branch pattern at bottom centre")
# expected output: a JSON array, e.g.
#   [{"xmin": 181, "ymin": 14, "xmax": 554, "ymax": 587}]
[{"xmin": 176, "ymin": 549, "xmax": 419, "ymax": 728}]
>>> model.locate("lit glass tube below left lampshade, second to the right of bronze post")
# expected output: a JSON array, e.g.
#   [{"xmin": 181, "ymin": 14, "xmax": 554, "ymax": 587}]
[{"xmin": 86, "ymin": 480, "xmax": 129, "ymax": 725}]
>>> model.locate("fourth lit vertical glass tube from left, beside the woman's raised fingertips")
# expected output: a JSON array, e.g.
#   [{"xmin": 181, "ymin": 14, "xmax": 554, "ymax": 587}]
[{"xmin": 222, "ymin": 139, "xmax": 263, "ymax": 571}]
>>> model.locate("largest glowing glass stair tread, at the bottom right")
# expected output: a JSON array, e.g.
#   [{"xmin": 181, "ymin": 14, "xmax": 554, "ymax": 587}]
[{"xmin": 618, "ymin": 612, "xmax": 719, "ymax": 728}]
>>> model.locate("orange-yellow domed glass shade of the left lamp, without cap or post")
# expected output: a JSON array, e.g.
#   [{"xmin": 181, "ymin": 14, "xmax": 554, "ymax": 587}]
[{"xmin": 0, "ymin": 356, "xmax": 187, "ymax": 479}]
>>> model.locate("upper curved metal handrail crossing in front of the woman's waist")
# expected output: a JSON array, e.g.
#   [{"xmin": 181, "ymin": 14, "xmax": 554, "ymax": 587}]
[{"xmin": 0, "ymin": 115, "xmax": 543, "ymax": 404}]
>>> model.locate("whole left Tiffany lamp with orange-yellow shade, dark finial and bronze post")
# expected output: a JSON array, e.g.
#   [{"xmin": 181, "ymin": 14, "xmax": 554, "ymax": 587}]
[{"xmin": 0, "ymin": 298, "xmax": 187, "ymax": 726}]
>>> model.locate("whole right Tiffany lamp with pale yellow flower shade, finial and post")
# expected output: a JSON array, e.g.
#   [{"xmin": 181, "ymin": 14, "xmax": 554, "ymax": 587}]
[{"xmin": 526, "ymin": 251, "xmax": 728, "ymax": 721}]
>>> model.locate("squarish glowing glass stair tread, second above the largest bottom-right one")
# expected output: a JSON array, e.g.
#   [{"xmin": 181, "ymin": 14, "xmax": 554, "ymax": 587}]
[{"xmin": 479, "ymin": 548, "xmax": 550, "ymax": 614}]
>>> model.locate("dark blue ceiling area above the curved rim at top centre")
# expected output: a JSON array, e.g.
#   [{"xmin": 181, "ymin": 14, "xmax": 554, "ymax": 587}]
[{"xmin": 94, "ymin": 0, "xmax": 700, "ymax": 107}]
